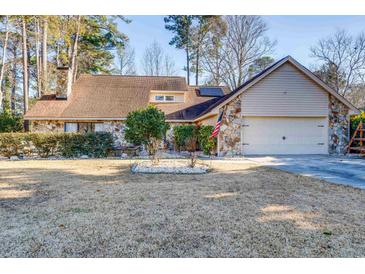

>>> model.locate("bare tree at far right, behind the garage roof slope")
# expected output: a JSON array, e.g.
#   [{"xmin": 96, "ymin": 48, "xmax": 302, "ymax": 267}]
[{"xmin": 311, "ymin": 30, "xmax": 365, "ymax": 96}]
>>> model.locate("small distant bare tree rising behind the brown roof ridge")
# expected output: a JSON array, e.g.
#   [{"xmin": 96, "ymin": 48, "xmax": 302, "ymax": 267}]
[{"xmin": 141, "ymin": 41, "xmax": 176, "ymax": 76}]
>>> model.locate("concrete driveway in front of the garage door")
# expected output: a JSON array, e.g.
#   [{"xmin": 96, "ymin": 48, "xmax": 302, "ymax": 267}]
[{"xmin": 245, "ymin": 155, "xmax": 365, "ymax": 189}]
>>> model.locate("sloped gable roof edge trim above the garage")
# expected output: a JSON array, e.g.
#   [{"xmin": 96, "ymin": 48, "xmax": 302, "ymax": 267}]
[{"xmin": 195, "ymin": 55, "xmax": 360, "ymax": 122}]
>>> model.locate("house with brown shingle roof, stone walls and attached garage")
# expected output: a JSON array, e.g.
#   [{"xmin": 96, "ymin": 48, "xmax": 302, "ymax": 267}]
[{"xmin": 25, "ymin": 56, "xmax": 358, "ymax": 156}]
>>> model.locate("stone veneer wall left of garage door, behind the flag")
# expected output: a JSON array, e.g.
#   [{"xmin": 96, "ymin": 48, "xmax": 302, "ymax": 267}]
[{"xmin": 218, "ymin": 96, "xmax": 242, "ymax": 157}]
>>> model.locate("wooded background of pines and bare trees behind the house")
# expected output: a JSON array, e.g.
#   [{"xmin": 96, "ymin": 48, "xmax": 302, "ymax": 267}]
[{"xmin": 0, "ymin": 15, "xmax": 365, "ymax": 130}]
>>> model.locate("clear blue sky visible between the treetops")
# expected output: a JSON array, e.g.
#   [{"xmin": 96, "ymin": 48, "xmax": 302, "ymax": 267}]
[{"xmin": 119, "ymin": 15, "xmax": 365, "ymax": 76}]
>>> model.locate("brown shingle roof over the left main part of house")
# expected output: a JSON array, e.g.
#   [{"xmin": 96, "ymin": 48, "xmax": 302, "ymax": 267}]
[{"xmin": 24, "ymin": 75, "xmax": 229, "ymax": 120}]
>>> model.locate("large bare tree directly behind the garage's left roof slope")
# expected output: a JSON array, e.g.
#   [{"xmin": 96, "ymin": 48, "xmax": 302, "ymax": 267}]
[{"xmin": 203, "ymin": 15, "xmax": 276, "ymax": 89}]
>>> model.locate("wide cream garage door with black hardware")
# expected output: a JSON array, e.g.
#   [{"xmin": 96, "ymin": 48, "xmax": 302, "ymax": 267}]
[{"xmin": 242, "ymin": 117, "xmax": 328, "ymax": 155}]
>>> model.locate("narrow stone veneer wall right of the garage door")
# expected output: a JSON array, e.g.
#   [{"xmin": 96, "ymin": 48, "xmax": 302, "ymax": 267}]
[{"xmin": 328, "ymin": 95, "xmax": 350, "ymax": 154}]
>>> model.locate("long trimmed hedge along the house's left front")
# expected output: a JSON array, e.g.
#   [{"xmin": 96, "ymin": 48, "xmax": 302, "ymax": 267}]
[{"xmin": 0, "ymin": 132, "xmax": 113, "ymax": 158}]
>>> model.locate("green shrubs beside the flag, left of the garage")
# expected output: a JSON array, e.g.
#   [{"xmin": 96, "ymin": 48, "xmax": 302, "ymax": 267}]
[{"xmin": 174, "ymin": 125, "xmax": 216, "ymax": 155}]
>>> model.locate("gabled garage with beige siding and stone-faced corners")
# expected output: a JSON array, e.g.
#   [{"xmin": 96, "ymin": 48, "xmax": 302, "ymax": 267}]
[{"xmin": 207, "ymin": 56, "xmax": 359, "ymax": 157}]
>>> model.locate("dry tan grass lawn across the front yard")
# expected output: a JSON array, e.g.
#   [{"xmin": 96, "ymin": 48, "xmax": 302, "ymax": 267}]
[{"xmin": 0, "ymin": 160, "xmax": 365, "ymax": 257}]
